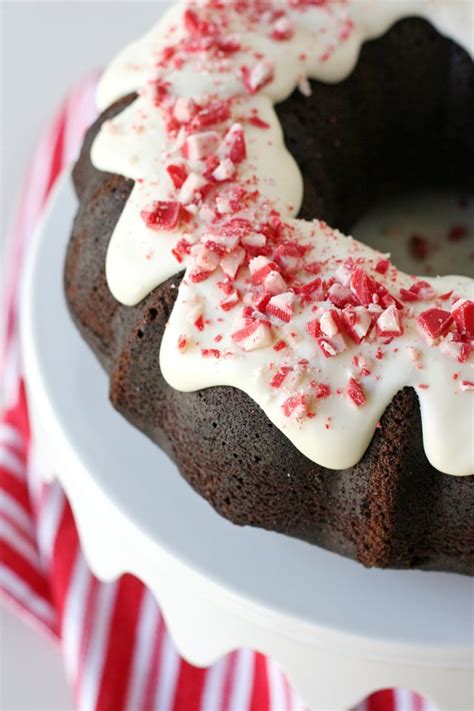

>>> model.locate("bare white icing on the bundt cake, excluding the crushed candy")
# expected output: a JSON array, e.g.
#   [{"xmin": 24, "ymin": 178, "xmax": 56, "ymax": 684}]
[{"xmin": 92, "ymin": 0, "xmax": 474, "ymax": 475}]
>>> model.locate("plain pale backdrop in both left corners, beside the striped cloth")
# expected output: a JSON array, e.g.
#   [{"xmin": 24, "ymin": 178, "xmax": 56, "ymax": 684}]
[{"xmin": 0, "ymin": 0, "xmax": 166, "ymax": 711}]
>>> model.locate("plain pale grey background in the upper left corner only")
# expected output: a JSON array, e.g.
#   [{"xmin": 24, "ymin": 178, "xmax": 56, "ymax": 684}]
[{"xmin": 0, "ymin": 0, "xmax": 167, "ymax": 264}]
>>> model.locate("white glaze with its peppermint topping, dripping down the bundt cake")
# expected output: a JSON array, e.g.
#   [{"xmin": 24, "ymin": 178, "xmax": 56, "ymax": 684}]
[{"xmin": 92, "ymin": 0, "xmax": 474, "ymax": 475}]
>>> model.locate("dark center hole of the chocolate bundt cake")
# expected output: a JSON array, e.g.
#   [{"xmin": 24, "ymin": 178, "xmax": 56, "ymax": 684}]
[{"xmin": 276, "ymin": 18, "xmax": 474, "ymax": 276}]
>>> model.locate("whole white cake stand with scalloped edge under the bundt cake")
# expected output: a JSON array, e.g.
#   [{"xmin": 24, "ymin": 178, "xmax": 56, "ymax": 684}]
[{"xmin": 22, "ymin": 176, "xmax": 474, "ymax": 710}]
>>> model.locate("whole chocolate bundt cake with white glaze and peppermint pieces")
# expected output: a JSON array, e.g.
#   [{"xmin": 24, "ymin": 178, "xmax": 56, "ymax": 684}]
[{"xmin": 65, "ymin": 0, "xmax": 474, "ymax": 574}]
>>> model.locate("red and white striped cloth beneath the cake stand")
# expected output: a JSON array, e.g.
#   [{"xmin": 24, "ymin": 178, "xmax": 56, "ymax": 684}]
[{"xmin": 0, "ymin": 76, "xmax": 427, "ymax": 711}]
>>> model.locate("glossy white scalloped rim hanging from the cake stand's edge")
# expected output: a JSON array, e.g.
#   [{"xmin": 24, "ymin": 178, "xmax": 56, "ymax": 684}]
[{"xmin": 21, "ymin": 176, "xmax": 473, "ymax": 709}]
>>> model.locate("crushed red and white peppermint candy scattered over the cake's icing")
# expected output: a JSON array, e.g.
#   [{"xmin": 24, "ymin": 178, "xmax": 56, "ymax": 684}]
[{"xmin": 94, "ymin": 0, "xmax": 474, "ymax": 468}]
